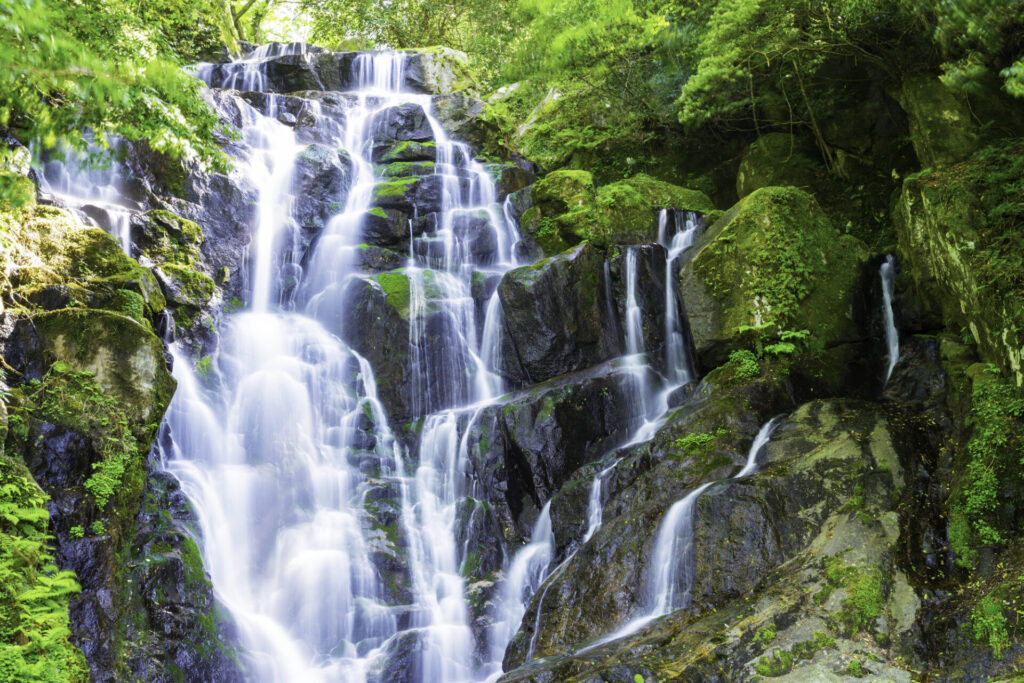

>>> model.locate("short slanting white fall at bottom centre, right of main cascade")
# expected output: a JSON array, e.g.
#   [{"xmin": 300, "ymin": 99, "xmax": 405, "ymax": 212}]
[{"xmin": 490, "ymin": 501, "xmax": 555, "ymax": 679}]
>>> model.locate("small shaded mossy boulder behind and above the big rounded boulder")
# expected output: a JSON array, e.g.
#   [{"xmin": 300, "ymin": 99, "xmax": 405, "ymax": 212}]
[{"xmin": 736, "ymin": 133, "xmax": 820, "ymax": 198}]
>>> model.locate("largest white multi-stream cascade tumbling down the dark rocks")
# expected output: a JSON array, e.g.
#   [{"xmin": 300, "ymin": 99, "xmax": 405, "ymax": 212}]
[{"xmin": 165, "ymin": 46, "xmax": 528, "ymax": 681}]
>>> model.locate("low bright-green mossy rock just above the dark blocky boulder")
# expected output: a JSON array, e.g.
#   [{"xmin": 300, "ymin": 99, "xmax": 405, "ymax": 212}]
[{"xmin": 522, "ymin": 170, "xmax": 714, "ymax": 254}]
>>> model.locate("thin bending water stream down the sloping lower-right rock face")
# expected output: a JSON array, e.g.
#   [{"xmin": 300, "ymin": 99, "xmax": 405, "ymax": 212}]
[{"xmin": 581, "ymin": 416, "xmax": 784, "ymax": 651}]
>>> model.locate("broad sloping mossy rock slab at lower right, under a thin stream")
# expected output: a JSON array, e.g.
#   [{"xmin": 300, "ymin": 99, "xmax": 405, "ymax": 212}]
[{"xmin": 503, "ymin": 401, "xmax": 922, "ymax": 682}]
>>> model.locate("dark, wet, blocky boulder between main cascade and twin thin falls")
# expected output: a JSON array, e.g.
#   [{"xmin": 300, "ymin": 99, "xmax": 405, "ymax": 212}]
[{"xmin": 498, "ymin": 244, "xmax": 620, "ymax": 382}]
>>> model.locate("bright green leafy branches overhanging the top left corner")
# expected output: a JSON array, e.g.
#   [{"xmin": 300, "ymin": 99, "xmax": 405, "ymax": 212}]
[{"xmin": 0, "ymin": 0, "xmax": 232, "ymax": 202}]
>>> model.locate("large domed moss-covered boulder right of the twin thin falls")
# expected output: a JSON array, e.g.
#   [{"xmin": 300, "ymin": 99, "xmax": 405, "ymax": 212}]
[{"xmin": 681, "ymin": 187, "xmax": 867, "ymax": 367}]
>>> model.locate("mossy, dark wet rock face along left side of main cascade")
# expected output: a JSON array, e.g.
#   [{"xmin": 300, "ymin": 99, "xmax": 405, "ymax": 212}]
[{"xmin": 0, "ymin": 198, "xmax": 240, "ymax": 681}]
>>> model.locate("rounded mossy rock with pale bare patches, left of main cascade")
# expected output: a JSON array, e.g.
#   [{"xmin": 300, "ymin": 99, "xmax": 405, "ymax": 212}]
[{"xmin": 32, "ymin": 308, "xmax": 175, "ymax": 425}]
